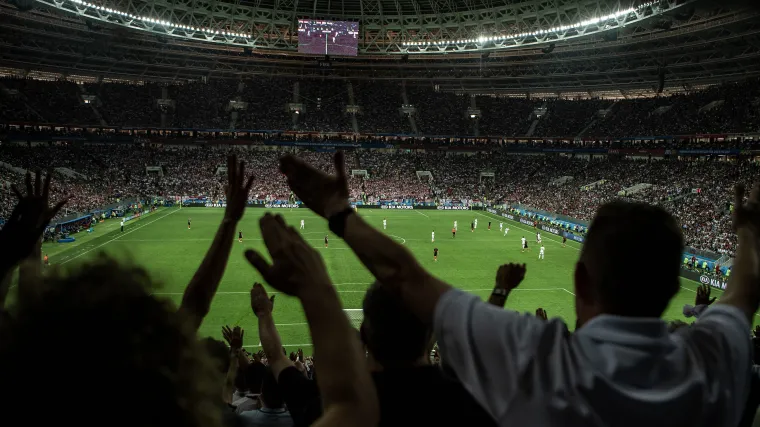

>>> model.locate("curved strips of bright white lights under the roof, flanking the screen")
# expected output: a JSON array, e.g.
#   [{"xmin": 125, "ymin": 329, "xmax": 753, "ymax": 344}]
[{"xmin": 49, "ymin": 0, "xmax": 676, "ymax": 53}]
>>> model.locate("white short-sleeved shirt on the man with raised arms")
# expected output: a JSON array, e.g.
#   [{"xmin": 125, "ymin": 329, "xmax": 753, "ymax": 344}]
[{"xmin": 435, "ymin": 290, "xmax": 752, "ymax": 427}]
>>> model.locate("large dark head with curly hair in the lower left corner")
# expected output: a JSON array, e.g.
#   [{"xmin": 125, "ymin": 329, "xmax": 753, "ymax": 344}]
[{"xmin": 0, "ymin": 256, "xmax": 221, "ymax": 426}]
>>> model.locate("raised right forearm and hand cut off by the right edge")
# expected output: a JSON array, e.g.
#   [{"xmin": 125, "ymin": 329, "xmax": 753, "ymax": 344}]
[{"xmin": 717, "ymin": 183, "xmax": 760, "ymax": 325}]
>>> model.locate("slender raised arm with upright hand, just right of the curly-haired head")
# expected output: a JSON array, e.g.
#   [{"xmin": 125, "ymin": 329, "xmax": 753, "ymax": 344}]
[{"xmin": 179, "ymin": 155, "xmax": 253, "ymax": 330}]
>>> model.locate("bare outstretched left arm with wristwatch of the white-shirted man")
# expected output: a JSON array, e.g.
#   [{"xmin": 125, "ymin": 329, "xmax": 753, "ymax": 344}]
[{"xmin": 281, "ymin": 152, "xmax": 450, "ymax": 324}]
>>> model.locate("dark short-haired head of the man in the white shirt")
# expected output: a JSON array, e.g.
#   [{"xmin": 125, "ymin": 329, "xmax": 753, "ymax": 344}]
[{"xmin": 575, "ymin": 201, "xmax": 683, "ymax": 325}]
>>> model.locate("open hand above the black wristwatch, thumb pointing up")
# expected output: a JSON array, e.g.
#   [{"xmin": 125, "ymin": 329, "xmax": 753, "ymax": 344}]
[{"xmin": 280, "ymin": 151, "xmax": 350, "ymax": 218}]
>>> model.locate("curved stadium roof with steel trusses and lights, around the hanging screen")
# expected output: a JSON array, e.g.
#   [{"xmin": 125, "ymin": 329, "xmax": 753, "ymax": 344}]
[{"xmin": 0, "ymin": 0, "xmax": 760, "ymax": 96}]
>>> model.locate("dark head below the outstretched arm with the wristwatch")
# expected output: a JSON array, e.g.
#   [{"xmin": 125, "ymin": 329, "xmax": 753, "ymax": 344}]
[{"xmin": 361, "ymin": 282, "xmax": 432, "ymax": 369}]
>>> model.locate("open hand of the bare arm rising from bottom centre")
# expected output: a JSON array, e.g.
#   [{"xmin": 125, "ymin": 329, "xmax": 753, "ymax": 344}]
[{"xmin": 245, "ymin": 214, "xmax": 332, "ymax": 296}]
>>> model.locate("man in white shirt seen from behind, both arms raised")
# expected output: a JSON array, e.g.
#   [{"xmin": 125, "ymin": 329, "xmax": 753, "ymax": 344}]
[{"xmin": 282, "ymin": 153, "xmax": 760, "ymax": 427}]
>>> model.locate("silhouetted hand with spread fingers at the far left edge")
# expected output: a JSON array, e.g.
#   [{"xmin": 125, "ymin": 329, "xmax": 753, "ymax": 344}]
[{"xmin": 0, "ymin": 170, "xmax": 66, "ymax": 266}]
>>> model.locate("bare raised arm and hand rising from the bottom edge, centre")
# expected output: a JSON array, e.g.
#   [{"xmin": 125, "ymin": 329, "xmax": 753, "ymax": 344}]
[{"xmin": 246, "ymin": 214, "xmax": 378, "ymax": 426}]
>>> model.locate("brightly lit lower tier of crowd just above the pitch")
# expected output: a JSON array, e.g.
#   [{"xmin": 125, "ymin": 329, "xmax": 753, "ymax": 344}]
[{"xmin": 0, "ymin": 144, "xmax": 760, "ymax": 255}]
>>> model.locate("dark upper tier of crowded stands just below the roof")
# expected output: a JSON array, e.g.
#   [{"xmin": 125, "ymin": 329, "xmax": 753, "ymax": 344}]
[{"xmin": 0, "ymin": 77, "xmax": 760, "ymax": 138}]
